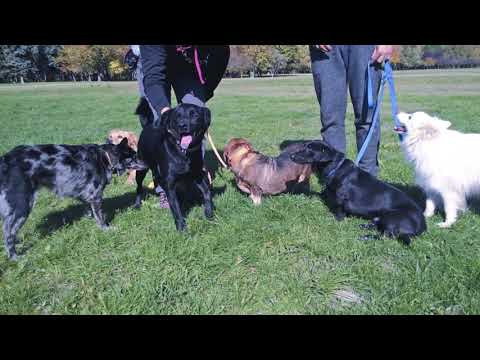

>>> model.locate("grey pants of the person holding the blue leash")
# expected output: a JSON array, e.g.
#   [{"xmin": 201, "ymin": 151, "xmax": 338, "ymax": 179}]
[{"xmin": 310, "ymin": 45, "xmax": 382, "ymax": 176}]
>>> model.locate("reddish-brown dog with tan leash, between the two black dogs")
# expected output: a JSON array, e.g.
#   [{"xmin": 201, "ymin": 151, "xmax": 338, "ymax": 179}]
[{"xmin": 223, "ymin": 138, "xmax": 312, "ymax": 205}]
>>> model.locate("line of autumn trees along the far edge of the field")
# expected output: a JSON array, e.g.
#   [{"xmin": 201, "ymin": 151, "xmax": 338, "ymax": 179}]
[{"xmin": 0, "ymin": 45, "xmax": 480, "ymax": 83}]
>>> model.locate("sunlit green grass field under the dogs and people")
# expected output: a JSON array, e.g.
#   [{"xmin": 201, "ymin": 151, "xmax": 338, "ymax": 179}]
[{"xmin": 0, "ymin": 70, "xmax": 480, "ymax": 314}]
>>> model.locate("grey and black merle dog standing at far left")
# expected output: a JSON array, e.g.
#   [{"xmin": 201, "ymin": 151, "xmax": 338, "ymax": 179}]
[{"xmin": 0, "ymin": 139, "xmax": 145, "ymax": 260}]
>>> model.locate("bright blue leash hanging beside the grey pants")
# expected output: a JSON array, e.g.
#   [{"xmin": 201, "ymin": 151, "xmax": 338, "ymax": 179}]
[{"xmin": 355, "ymin": 61, "xmax": 403, "ymax": 166}]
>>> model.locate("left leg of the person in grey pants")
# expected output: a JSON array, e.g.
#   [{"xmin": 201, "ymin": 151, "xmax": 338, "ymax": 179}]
[{"xmin": 310, "ymin": 45, "xmax": 348, "ymax": 153}]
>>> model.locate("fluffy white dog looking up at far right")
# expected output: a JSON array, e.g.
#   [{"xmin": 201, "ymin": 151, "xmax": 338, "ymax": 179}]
[{"xmin": 396, "ymin": 112, "xmax": 480, "ymax": 228}]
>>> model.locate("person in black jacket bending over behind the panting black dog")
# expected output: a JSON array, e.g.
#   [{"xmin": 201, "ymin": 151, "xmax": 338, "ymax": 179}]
[{"xmin": 126, "ymin": 45, "xmax": 230, "ymax": 207}]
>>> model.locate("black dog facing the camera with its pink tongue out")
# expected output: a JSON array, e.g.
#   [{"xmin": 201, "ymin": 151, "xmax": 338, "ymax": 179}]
[{"xmin": 135, "ymin": 99, "xmax": 213, "ymax": 231}]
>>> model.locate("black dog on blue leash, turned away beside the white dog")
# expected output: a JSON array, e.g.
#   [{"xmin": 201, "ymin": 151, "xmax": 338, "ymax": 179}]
[{"xmin": 291, "ymin": 140, "xmax": 427, "ymax": 245}]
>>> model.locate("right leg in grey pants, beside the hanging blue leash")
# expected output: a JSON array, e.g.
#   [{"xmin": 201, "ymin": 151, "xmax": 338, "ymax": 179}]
[{"xmin": 348, "ymin": 45, "xmax": 382, "ymax": 176}]
